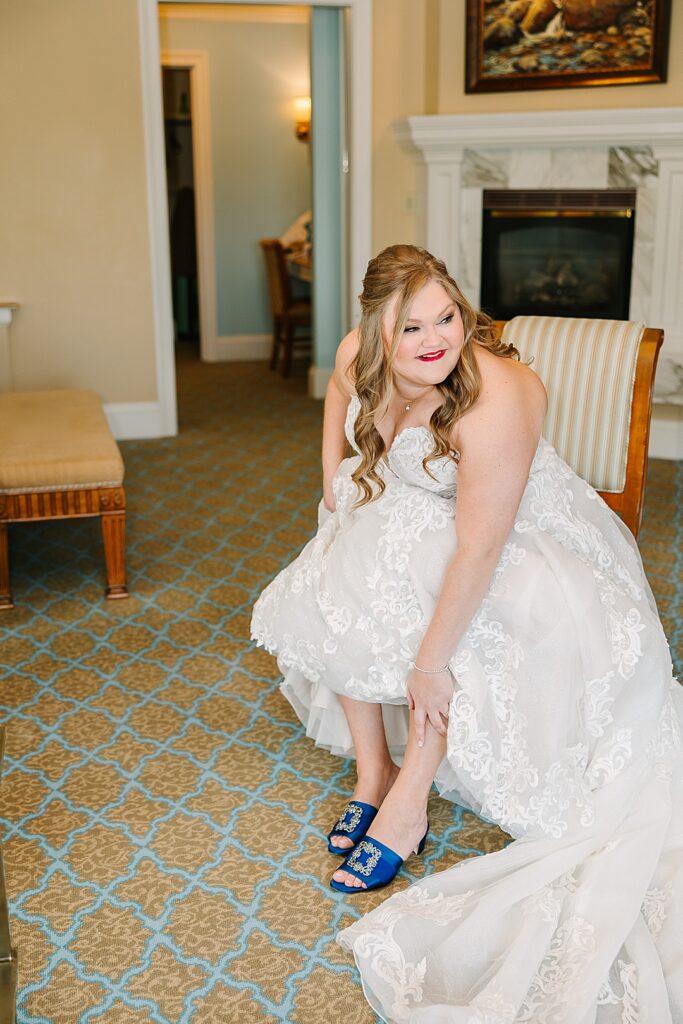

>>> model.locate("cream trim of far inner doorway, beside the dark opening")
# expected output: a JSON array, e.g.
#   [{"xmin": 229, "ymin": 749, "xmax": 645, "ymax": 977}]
[{"xmin": 161, "ymin": 50, "xmax": 218, "ymax": 362}]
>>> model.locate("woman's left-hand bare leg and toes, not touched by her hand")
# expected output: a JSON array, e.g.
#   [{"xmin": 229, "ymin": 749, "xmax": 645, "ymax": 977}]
[{"xmin": 330, "ymin": 695, "xmax": 398, "ymax": 850}]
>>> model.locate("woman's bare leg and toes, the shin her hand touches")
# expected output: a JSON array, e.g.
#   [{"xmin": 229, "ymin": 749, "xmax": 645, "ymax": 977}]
[{"xmin": 333, "ymin": 713, "xmax": 445, "ymax": 888}]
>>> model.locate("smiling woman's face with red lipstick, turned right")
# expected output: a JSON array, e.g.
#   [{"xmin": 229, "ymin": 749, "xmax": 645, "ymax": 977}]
[{"xmin": 382, "ymin": 281, "xmax": 465, "ymax": 384}]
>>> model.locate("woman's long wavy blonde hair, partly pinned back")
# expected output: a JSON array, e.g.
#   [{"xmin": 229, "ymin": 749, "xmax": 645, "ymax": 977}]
[{"xmin": 349, "ymin": 245, "xmax": 519, "ymax": 508}]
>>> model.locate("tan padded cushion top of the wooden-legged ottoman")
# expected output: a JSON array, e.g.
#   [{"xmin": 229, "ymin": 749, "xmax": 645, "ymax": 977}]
[{"xmin": 0, "ymin": 390, "xmax": 124, "ymax": 494}]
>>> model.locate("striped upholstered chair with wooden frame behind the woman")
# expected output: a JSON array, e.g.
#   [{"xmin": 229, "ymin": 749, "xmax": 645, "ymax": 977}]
[{"xmin": 497, "ymin": 316, "xmax": 664, "ymax": 540}]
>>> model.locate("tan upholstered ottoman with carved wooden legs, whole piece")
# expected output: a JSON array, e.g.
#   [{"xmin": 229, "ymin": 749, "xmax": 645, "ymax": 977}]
[{"xmin": 0, "ymin": 391, "xmax": 128, "ymax": 608}]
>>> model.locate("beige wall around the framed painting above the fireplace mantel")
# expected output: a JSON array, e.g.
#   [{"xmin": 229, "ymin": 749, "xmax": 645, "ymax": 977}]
[{"xmin": 373, "ymin": 0, "xmax": 683, "ymax": 252}]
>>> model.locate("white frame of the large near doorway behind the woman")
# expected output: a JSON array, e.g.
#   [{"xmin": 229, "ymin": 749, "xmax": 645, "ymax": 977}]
[{"xmin": 137, "ymin": 0, "xmax": 373, "ymax": 434}]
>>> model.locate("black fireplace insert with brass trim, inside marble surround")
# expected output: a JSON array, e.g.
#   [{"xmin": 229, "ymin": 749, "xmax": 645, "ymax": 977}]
[{"xmin": 481, "ymin": 188, "xmax": 636, "ymax": 319}]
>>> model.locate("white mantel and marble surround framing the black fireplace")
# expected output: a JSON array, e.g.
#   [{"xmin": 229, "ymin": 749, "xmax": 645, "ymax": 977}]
[{"xmin": 394, "ymin": 106, "xmax": 683, "ymax": 459}]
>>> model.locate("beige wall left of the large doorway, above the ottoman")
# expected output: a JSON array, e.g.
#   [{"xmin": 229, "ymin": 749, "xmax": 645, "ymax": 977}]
[{"xmin": 0, "ymin": 0, "xmax": 157, "ymax": 402}]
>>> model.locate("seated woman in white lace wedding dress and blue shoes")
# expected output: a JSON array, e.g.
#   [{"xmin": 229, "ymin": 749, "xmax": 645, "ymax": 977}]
[{"xmin": 252, "ymin": 246, "xmax": 683, "ymax": 1024}]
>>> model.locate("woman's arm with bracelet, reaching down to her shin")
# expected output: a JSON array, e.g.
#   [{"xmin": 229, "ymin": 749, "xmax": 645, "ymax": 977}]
[{"xmin": 408, "ymin": 360, "xmax": 546, "ymax": 742}]
